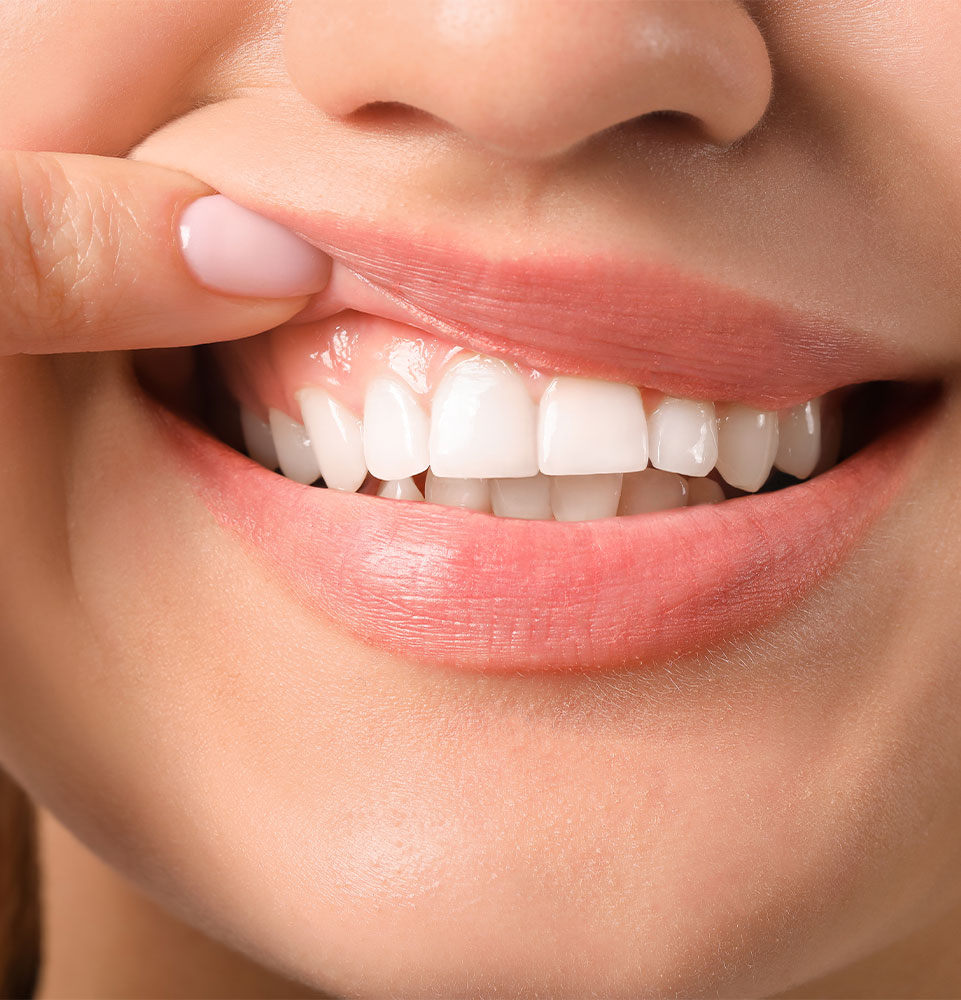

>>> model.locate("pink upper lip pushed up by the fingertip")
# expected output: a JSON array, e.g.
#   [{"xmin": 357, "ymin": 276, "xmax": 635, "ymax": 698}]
[{"xmin": 240, "ymin": 206, "xmax": 904, "ymax": 409}]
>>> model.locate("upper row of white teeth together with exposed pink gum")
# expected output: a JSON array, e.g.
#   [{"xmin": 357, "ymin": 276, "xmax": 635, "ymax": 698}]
[{"xmin": 223, "ymin": 314, "xmax": 821, "ymax": 500}]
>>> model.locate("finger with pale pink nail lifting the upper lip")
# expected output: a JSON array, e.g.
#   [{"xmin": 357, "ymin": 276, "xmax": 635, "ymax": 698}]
[{"xmin": 0, "ymin": 152, "xmax": 330, "ymax": 355}]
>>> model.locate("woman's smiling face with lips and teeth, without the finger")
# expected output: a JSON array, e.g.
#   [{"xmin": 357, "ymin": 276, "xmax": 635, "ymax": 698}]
[{"xmin": 0, "ymin": 0, "xmax": 961, "ymax": 996}]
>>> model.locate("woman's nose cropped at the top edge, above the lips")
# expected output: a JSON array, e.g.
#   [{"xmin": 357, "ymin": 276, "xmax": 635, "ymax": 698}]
[{"xmin": 284, "ymin": 0, "xmax": 771, "ymax": 159}]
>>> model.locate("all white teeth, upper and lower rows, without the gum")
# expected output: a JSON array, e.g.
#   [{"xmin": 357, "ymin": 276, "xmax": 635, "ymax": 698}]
[{"xmin": 241, "ymin": 355, "xmax": 837, "ymax": 508}]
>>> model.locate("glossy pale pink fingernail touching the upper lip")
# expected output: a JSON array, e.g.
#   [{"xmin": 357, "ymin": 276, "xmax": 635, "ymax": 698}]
[{"xmin": 180, "ymin": 194, "xmax": 331, "ymax": 299}]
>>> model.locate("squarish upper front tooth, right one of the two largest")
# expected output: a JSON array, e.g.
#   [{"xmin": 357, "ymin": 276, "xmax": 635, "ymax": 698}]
[{"xmin": 537, "ymin": 376, "xmax": 647, "ymax": 476}]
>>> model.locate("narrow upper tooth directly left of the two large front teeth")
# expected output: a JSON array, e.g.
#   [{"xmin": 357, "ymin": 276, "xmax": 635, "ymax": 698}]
[{"xmin": 364, "ymin": 377, "xmax": 430, "ymax": 479}]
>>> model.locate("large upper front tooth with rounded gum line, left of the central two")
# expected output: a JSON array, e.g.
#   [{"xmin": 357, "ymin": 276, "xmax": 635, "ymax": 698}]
[{"xmin": 430, "ymin": 357, "xmax": 537, "ymax": 479}]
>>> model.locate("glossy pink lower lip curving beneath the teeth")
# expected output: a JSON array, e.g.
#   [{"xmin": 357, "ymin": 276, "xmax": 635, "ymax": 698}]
[{"xmin": 156, "ymin": 396, "xmax": 930, "ymax": 673}]
